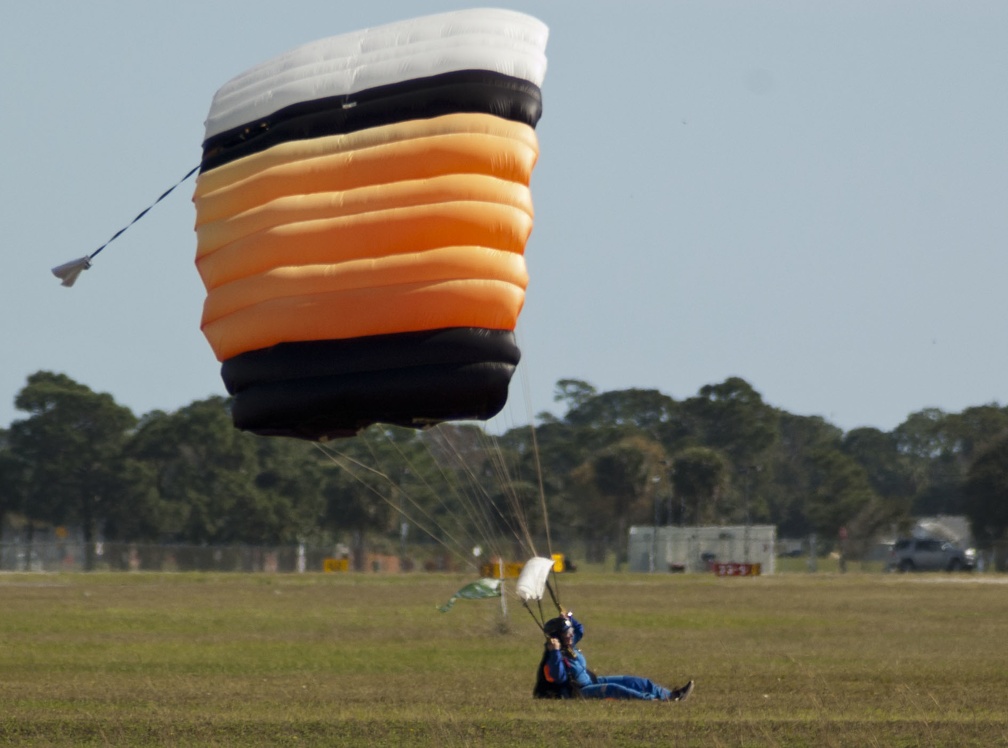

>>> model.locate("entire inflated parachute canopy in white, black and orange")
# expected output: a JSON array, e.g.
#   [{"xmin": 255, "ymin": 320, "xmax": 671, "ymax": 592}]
[{"xmin": 194, "ymin": 10, "xmax": 547, "ymax": 440}]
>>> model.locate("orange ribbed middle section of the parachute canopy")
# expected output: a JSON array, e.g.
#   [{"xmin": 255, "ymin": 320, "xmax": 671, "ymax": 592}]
[{"xmin": 194, "ymin": 114, "xmax": 538, "ymax": 361}]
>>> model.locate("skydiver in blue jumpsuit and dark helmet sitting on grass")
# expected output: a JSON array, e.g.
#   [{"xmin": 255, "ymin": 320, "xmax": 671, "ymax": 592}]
[{"xmin": 532, "ymin": 613, "xmax": 694, "ymax": 702}]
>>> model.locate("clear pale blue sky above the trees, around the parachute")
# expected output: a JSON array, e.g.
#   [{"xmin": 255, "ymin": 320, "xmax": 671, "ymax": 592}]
[{"xmin": 0, "ymin": 0, "xmax": 1008, "ymax": 429}]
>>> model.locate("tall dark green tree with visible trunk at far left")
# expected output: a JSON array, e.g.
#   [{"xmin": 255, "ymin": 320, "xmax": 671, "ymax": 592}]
[{"xmin": 9, "ymin": 371, "xmax": 136, "ymax": 570}]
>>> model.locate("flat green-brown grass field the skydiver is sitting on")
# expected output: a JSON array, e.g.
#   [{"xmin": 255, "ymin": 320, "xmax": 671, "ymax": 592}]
[{"xmin": 0, "ymin": 572, "xmax": 1008, "ymax": 747}]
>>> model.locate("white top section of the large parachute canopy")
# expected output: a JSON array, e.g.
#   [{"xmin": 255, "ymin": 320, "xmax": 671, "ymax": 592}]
[{"xmin": 205, "ymin": 8, "xmax": 548, "ymax": 138}]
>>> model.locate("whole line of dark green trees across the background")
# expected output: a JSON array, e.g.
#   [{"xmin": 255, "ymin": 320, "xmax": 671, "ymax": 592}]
[{"xmin": 0, "ymin": 371, "xmax": 1008, "ymax": 572}]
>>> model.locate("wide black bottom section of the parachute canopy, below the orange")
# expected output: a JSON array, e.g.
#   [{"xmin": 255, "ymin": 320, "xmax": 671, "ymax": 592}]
[{"xmin": 221, "ymin": 328, "xmax": 520, "ymax": 441}]
